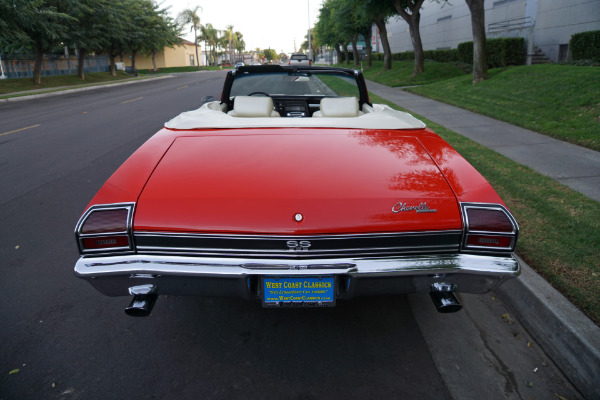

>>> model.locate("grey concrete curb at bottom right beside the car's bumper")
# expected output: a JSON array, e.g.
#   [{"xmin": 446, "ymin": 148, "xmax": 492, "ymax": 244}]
[{"xmin": 496, "ymin": 258, "xmax": 600, "ymax": 399}]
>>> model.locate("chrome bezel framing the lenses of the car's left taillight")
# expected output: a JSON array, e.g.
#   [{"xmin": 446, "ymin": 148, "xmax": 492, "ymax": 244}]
[{"xmin": 75, "ymin": 203, "xmax": 135, "ymax": 255}]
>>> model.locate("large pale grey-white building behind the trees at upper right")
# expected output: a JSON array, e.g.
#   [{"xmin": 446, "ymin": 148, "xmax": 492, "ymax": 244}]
[{"xmin": 377, "ymin": 0, "xmax": 600, "ymax": 61}]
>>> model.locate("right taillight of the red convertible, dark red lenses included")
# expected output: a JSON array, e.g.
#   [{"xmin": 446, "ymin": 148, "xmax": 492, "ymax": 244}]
[{"xmin": 461, "ymin": 203, "xmax": 519, "ymax": 252}]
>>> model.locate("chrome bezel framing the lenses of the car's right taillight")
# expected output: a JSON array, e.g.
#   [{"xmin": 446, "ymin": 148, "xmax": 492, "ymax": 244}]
[{"xmin": 461, "ymin": 203, "xmax": 519, "ymax": 253}]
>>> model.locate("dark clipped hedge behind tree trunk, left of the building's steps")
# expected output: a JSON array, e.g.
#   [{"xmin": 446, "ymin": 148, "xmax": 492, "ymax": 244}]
[{"xmin": 458, "ymin": 38, "xmax": 526, "ymax": 68}]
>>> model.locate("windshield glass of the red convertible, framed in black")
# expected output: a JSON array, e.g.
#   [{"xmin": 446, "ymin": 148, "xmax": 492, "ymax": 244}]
[{"xmin": 230, "ymin": 72, "xmax": 360, "ymax": 97}]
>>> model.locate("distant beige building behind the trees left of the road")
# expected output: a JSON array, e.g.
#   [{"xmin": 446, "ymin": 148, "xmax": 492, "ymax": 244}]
[{"xmin": 123, "ymin": 40, "xmax": 203, "ymax": 69}]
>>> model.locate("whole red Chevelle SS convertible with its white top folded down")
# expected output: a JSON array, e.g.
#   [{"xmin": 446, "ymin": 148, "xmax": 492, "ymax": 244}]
[{"xmin": 75, "ymin": 66, "xmax": 520, "ymax": 316}]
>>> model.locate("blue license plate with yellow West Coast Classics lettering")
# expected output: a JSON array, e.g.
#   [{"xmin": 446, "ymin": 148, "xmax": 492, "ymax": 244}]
[{"xmin": 262, "ymin": 275, "xmax": 335, "ymax": 307}]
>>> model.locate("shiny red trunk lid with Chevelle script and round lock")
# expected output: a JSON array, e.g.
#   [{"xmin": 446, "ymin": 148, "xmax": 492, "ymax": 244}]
[{"xmin": 134, "ymin": 129, "xmax": 461, "ymax": 234}]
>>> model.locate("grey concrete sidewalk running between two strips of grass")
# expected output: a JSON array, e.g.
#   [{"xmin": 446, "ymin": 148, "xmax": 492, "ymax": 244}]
[{"xmin": 367, "ymin": 81, "xmax": 600, "ymax": 201}]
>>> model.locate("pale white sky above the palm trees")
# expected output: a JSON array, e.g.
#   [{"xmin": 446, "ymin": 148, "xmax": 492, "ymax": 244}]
[{"xmin": 158, "ymin": 0, "xmax": 323, "ymax": 53}]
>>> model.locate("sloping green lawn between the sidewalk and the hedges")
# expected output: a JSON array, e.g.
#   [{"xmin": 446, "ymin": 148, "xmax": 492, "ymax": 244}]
[{"xmin": 406, "ymin": 64, "xmax": 600, "ymax": 151}]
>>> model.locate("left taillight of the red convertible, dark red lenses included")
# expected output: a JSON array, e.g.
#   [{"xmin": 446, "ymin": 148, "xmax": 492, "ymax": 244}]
[{"xmin": 75, "ymin": 203, "xmax": 134, "ymax": 254}]
